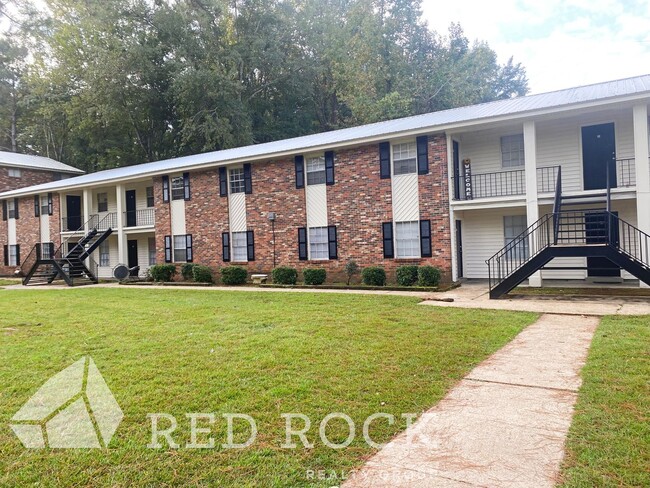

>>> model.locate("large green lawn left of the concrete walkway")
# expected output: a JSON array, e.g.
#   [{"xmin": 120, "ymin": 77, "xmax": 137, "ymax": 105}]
[{"xmin": 0, "ymin": 287, "xmax": 536, "ymax": 487}]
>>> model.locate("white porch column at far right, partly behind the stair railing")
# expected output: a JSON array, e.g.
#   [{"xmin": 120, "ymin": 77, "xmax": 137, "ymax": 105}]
[{"xmin": 632, "ymin": 104, "xmax": 650, "ymax": 288}]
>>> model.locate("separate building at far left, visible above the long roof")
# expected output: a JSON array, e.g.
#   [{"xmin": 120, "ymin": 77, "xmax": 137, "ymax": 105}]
[{"xmin": 0, "ymin": 151, "xmax": 84, "ymax": 192}]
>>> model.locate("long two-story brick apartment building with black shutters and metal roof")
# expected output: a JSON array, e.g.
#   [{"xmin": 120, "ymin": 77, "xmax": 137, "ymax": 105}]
[{"xmin": 0, "ymin": 75, "xmax": 650, "ymax": 294}]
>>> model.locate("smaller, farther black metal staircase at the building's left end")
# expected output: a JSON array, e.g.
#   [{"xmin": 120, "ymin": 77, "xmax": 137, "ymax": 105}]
[{"xmin": 21, "ymin": 214, "xmax": 113, "ymax": 286}]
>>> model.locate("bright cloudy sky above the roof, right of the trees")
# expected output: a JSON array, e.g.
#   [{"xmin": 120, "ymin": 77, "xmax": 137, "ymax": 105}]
[{"xmin": 422, "ymin": 0, "xmax": 650, "ymax": 93}]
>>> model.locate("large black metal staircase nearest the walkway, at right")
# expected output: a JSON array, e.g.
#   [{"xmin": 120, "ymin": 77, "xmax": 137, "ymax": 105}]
[{"xmin": 486, "ymin": 170, "xmax": 650, "ymax": 298}]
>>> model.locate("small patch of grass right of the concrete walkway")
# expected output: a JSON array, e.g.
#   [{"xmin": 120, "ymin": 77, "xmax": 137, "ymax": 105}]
[{"xmin": 561, "ymin": 316, "xmax": 650, "ymax": 487}]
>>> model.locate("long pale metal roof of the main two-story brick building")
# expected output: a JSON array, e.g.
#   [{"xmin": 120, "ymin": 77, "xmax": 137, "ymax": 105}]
[{"xmin": 0, "ymin": 75, "xmax": 650, "ymax": 198}]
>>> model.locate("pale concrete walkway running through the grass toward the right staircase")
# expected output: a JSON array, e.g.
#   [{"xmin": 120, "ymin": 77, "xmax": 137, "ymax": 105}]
[{"xmin": 343, "ymin": 315, "xmax": 599, "ymax": 488}]
